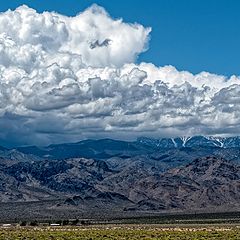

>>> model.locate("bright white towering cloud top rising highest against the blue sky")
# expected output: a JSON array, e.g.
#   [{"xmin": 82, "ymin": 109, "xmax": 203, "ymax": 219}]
[{"xmin": 0, "ymin": 5, "xmax": 151, "ymax": 67}]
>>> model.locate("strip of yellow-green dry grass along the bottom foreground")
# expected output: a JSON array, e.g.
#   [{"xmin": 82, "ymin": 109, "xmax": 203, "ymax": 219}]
[{"xmin": 0, "ymin": 225, "xmax": 240, "ymax": 240}]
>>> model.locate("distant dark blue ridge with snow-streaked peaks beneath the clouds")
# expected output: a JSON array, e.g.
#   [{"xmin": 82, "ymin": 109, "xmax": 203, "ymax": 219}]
[{"xmin": 10, "ymin": 136, "xmax": 240, "ymax": 159}]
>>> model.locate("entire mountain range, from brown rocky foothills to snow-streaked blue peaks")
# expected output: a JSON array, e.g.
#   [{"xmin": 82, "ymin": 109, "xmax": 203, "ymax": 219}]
[{"xmin": 0, "ymin": 136, "xmax": 240, "ymax": 219}]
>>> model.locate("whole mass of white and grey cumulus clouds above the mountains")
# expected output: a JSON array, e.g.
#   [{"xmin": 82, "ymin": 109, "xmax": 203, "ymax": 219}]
[{"xmin": 0, "ymin": 5, "xmax": 240, "ymax": 145}]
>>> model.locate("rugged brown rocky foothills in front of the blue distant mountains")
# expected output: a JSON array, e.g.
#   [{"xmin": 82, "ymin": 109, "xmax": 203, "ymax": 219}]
[{"xmin": 0, "ymin": 153, "xmax": 240, "ymax": 211}]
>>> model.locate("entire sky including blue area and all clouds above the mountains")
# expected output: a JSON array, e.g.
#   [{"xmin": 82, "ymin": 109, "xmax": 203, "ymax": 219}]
[{"xmin": 0, "ymin": 0, "xmax": 240, "ymax": 147}]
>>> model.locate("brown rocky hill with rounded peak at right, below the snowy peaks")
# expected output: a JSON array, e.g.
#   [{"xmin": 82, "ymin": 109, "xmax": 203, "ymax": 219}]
[{"xmin": 123, "ymin": 157, "xmax": 240, "ymax": 210}]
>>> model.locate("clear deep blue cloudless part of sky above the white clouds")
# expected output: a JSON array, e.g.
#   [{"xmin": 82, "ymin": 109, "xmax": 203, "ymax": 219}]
[{"xmin": 0, "ymin": 0, "xmax": 240, "ymax": 76}]
